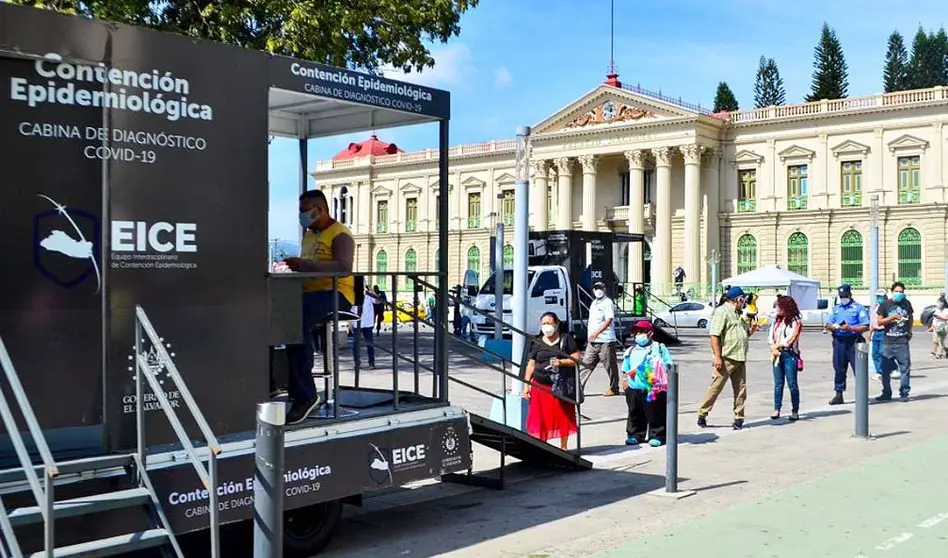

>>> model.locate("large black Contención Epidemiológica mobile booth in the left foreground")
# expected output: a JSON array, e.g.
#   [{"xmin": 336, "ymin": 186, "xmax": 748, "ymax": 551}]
[{"xmin": 0, "ymin": 4, "xmax": 471, "ymax": 556}]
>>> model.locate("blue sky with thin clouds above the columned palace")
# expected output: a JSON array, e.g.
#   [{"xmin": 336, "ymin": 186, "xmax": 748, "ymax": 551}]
[{"xmin": 270, "ymin": 0, "xmax": 948, "ymax": 238}]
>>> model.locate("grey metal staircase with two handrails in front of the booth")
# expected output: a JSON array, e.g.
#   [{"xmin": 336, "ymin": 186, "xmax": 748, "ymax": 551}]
[{"xmin": 0, "ymin": 307, "xmax": 220, "ymax": 558}]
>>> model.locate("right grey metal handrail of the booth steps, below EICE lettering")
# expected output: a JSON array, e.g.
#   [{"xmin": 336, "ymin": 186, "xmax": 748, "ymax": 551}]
[{"xmin": 135, "ymin": 304, "xmax": 223, "ymax": 558}]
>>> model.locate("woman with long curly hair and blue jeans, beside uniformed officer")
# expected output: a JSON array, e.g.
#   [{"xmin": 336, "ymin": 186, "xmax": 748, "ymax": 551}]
[{"xmin": 770, "ymin": 296, "xmax": 803, "ymax": 422}]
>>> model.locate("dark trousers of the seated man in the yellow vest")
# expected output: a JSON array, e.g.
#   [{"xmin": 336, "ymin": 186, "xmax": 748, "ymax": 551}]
[{"xmin": 286, "ymin": 291, "xmax": 352, "ymax": 401}]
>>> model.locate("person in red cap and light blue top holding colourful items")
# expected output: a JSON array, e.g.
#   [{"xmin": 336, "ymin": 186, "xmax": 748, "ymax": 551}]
[{"xmin": 621, "ymin": 320, "xmax": 672, "ymax": 447}]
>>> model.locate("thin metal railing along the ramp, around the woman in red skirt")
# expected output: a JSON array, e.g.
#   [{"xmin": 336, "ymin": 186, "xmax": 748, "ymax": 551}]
[{"xmin": 418, "ymin": 280, "xmax": 583, "ymax": 458}]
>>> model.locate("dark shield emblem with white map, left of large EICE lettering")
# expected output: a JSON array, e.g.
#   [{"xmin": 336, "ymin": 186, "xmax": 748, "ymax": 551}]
[{"xmin": 33, "ymin": 206, "xmax": 102, "ymax": 292}]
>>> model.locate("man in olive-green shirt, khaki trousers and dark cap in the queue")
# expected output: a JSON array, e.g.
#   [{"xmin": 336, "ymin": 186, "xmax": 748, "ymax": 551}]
[{"xmin": 698, "ymin": 287, "xmax": 757, "ymax": 430}]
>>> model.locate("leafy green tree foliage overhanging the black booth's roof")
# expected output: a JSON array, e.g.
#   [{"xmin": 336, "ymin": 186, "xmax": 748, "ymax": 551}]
[{"xmin": 12, "ymin": 0, "xmax": 480, "ymax": 71}]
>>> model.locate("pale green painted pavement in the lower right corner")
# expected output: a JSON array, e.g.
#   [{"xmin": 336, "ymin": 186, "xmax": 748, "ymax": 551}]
[{"xmin": 596, "ymin": 437, "xmax": 948, "ymax": 558}]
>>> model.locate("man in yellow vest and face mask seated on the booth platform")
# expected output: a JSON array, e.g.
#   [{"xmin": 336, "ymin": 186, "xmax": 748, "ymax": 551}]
[{"xmin": 286, "ymin": 190, "xmax": 355, "ymax": 424}]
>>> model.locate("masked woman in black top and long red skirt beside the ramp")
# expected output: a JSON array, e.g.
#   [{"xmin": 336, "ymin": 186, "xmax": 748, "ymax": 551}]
[{"xmin": 523, "ymin": 312, "xmax": 580, "ymax": 450}]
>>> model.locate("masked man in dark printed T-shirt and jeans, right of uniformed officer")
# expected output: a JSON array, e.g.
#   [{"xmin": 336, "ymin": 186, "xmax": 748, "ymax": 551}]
[{"xmin": 876, "ymin": 281, "xmax": 915, "ymax": 401}]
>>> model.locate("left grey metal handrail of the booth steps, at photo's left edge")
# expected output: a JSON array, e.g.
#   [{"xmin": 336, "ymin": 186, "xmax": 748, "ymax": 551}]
[{"xmin": 0, "ymin": 339, "xmax": 59, "ymax": 557}]
